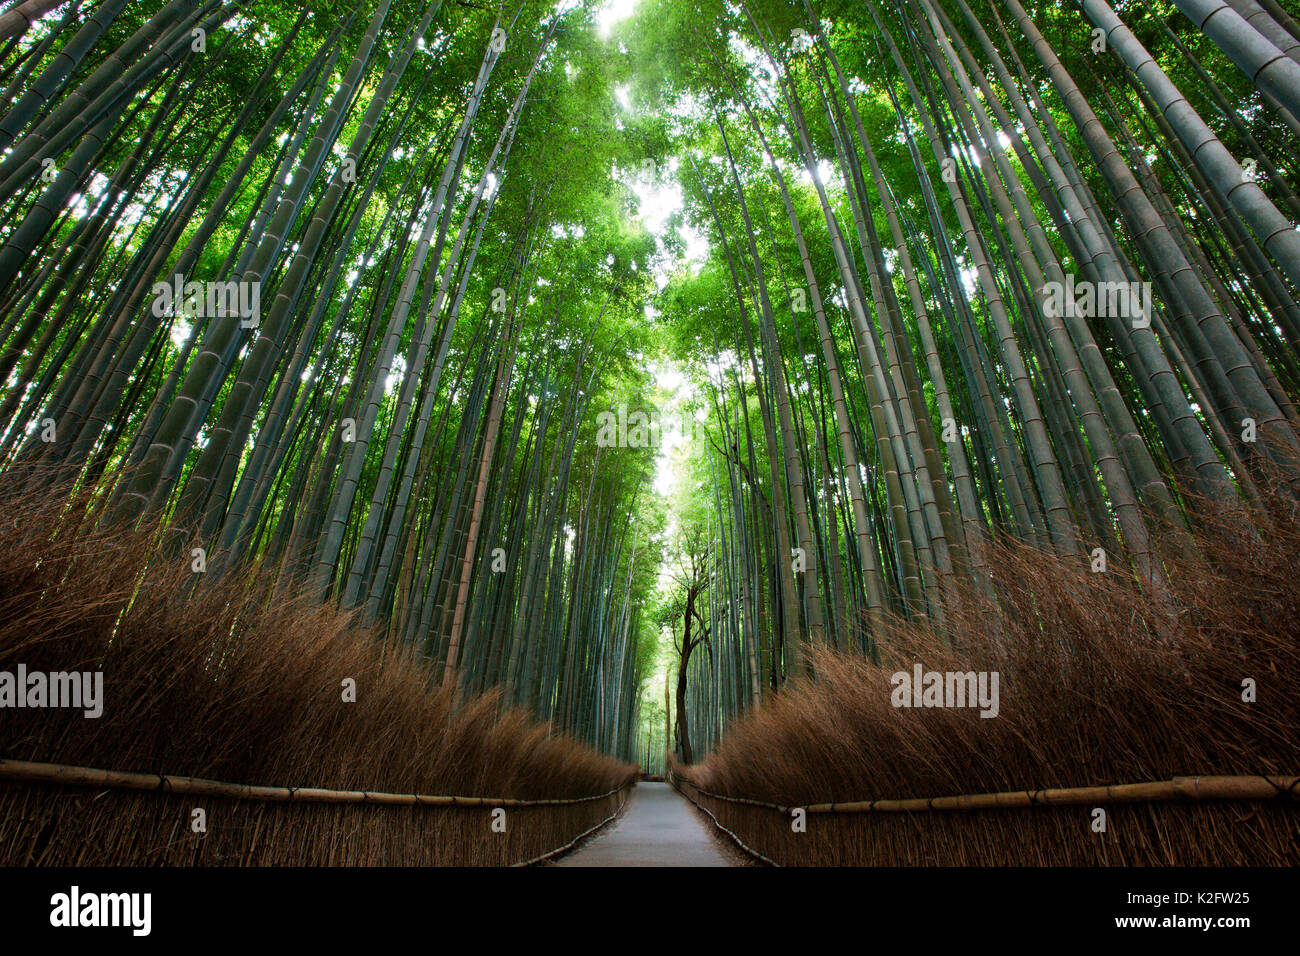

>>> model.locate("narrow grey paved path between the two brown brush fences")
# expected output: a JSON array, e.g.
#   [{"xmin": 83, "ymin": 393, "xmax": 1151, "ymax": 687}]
[{"xmin": 555, "ymin": 783, "xmax": 748, "ymax": 866}]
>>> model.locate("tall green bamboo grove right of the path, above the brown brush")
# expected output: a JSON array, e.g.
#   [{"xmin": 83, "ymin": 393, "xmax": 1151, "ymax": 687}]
[{"xmin": 640, "ymin": 0, "xmax": 1300, "ymax": 762}]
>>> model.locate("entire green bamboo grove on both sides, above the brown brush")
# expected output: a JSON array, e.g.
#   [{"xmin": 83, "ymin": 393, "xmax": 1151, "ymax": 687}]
[{"xmin": 0, "ymin": 0, "xmax": 1300, "ymax": 767}]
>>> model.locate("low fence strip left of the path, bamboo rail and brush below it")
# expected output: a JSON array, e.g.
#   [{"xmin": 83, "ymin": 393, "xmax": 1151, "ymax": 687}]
[{"xmin": 0, "ymin": 758, "xmax": 633, "ymax": 866}]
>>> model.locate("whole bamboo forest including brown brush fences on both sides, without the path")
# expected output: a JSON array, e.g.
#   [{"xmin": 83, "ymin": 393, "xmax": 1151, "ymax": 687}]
[{"xmin": 0, "ymin": 0, "xmax": 1300, "ymax": 884}]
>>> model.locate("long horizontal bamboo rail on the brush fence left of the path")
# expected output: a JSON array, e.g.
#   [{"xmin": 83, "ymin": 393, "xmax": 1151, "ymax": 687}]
[{"xmin": 0, "ymin": 757, "xmax": 628, "ymax": 808}]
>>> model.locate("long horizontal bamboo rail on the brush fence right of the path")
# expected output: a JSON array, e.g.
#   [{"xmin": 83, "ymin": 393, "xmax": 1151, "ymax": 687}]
[{"xmin": 670, "ymin": 774, "xmax": 1300, "ymax": 813}]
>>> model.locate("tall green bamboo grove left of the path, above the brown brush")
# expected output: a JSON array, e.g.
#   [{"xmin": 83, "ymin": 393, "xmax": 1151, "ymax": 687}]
[{"xmin": 0, "ymin": 0, "xmax": 670, "ymax": 753}]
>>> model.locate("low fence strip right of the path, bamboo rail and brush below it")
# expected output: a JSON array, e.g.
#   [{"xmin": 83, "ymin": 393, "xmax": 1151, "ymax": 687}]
[{"xmin": 668, "ymin": 771, "xmax": 1300, "ymax": 866}]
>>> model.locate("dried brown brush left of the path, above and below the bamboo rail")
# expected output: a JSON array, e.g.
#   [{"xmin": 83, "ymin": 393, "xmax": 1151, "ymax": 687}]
[{"xmin": 0, "ymin": 484, "xmax": 634, "ymax": 865}]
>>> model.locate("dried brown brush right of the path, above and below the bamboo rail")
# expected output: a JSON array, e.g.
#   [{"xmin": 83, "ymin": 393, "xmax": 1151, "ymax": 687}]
[{"xmin": 676, "ymin": 481, "xmax": 1300, "ymax": 865}]
